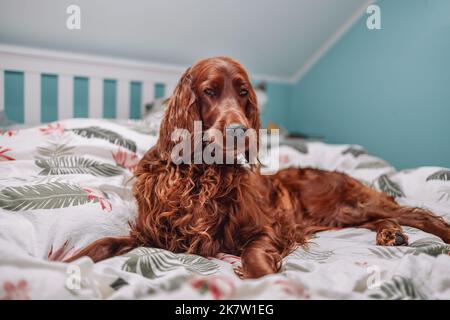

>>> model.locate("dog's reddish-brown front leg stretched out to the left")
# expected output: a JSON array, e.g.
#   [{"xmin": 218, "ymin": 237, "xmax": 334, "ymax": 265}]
[{"xmin": 64, "ymin": 236, "xmax": 139, "ymax": 262}]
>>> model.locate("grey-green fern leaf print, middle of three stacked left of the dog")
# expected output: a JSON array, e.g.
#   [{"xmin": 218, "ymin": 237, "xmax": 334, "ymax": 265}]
[{"xmin": 35, "ymin": 156, "xmax": 123, "ymax": 177}]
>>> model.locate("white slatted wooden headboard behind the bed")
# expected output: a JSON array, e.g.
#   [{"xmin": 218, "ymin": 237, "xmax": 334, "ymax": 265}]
[{"xmin": 0, "ymin": 44, "xmax": 184, "ymax": 124}]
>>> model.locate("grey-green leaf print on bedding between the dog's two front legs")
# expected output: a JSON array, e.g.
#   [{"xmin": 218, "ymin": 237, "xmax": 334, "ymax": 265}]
[{"xmin": 122, "ymin": 247, "xmax": 219, "ymax": 279}]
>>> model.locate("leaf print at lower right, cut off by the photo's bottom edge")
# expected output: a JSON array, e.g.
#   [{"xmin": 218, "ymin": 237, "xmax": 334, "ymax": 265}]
[{"xmin": 369, "ymin": 276, "xmax": 428, "ymax": 300}]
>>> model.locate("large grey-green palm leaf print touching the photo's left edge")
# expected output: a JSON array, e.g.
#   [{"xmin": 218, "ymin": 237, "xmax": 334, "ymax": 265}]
[{"xmin": 0, "ymin": 182, "xmax": 98, "ymax": 211}]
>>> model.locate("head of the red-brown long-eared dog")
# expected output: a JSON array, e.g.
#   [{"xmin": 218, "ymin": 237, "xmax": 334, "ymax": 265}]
[{"xmin": 158, "ymin": 57, "xmax": 260, "ymax": 164}]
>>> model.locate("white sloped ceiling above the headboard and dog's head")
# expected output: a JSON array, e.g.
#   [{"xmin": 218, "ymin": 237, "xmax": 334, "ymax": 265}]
[{"xmin": 0, "ymin": 0, "xmax": 367, "ymax": 78}]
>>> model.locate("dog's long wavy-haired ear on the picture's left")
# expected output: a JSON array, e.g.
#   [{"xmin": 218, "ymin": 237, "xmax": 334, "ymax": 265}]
[{"xmin": 158, "ymin": 68, "xmax": 201, "ymax": 159}]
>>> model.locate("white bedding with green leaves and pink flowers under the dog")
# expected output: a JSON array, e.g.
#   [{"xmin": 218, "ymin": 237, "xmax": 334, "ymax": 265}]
[{"xmin": 0, "ymin": 119, "xmax": 450, "ymax": 299}]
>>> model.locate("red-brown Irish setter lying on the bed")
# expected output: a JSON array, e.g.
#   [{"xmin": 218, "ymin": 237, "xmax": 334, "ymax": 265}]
[{"xmin": 68, "ymin": 57, "xmax": 450, "ymax": 278}]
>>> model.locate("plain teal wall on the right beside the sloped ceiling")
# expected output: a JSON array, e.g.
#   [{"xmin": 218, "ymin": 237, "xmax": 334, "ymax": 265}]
[{"xmin": 288, "ymin": 0, "xmax": 450, "ymax": 168}]
